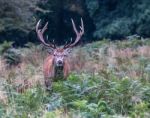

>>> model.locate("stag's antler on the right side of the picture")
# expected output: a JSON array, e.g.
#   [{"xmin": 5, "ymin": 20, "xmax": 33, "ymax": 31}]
[{"xmin": 64, "ymin": 18, "xmax": 84, "ymax": 48}]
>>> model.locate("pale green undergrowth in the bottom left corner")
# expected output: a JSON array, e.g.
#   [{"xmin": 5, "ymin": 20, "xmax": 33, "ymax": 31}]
[{"xmin": 0, "ymin": 84, "xmax": 45, "ymax": 118}]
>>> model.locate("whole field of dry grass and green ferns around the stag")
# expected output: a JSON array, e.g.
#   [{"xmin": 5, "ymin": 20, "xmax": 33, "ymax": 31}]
[{"xmin": 0, "ymin": 39, "xmax": 150, "ymax": 118}]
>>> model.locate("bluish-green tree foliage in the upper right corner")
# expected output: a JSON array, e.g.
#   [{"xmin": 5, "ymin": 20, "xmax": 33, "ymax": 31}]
[{"xmin": 86, "ymin": 0, "xmax": 150, "ymax": 38}]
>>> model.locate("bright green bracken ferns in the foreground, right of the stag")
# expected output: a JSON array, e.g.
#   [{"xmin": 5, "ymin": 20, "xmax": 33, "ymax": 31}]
[{"xmin": 44, "ymin": 75, "xmax": 149, "ymax": 118}]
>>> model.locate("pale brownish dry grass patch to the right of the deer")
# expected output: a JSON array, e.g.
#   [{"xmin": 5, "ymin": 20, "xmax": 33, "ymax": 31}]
[{"xmin": 72, "ymin": 40, "xmax": 150, "ymax": 79}]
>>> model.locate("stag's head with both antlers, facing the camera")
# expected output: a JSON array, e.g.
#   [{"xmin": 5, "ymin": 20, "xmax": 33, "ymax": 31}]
[{"xmin": 36, "ymin": 18, "xmax": 84, "ymax": 66}]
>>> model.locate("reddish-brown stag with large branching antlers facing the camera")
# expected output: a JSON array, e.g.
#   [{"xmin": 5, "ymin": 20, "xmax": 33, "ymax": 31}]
[{"xmin": 36, "ymin": 18, "xmax": 84, "ymax": 90}]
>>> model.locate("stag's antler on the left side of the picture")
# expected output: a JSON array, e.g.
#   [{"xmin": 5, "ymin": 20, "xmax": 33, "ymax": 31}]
[{"xmin": 36, "ymin": 20, "xmax": 56, "ymax": 49}]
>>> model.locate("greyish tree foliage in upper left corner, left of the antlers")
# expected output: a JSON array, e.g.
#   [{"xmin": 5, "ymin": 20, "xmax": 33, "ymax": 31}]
[{"xmin": 0, "ymin": 0, "xmax": 39, "ymax": 44}]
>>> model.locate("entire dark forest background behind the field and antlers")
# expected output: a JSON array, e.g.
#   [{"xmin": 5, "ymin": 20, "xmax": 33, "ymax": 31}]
[{"xmin": 0, "ymin": 0, "xmax": 150, "ymax": 46}]
